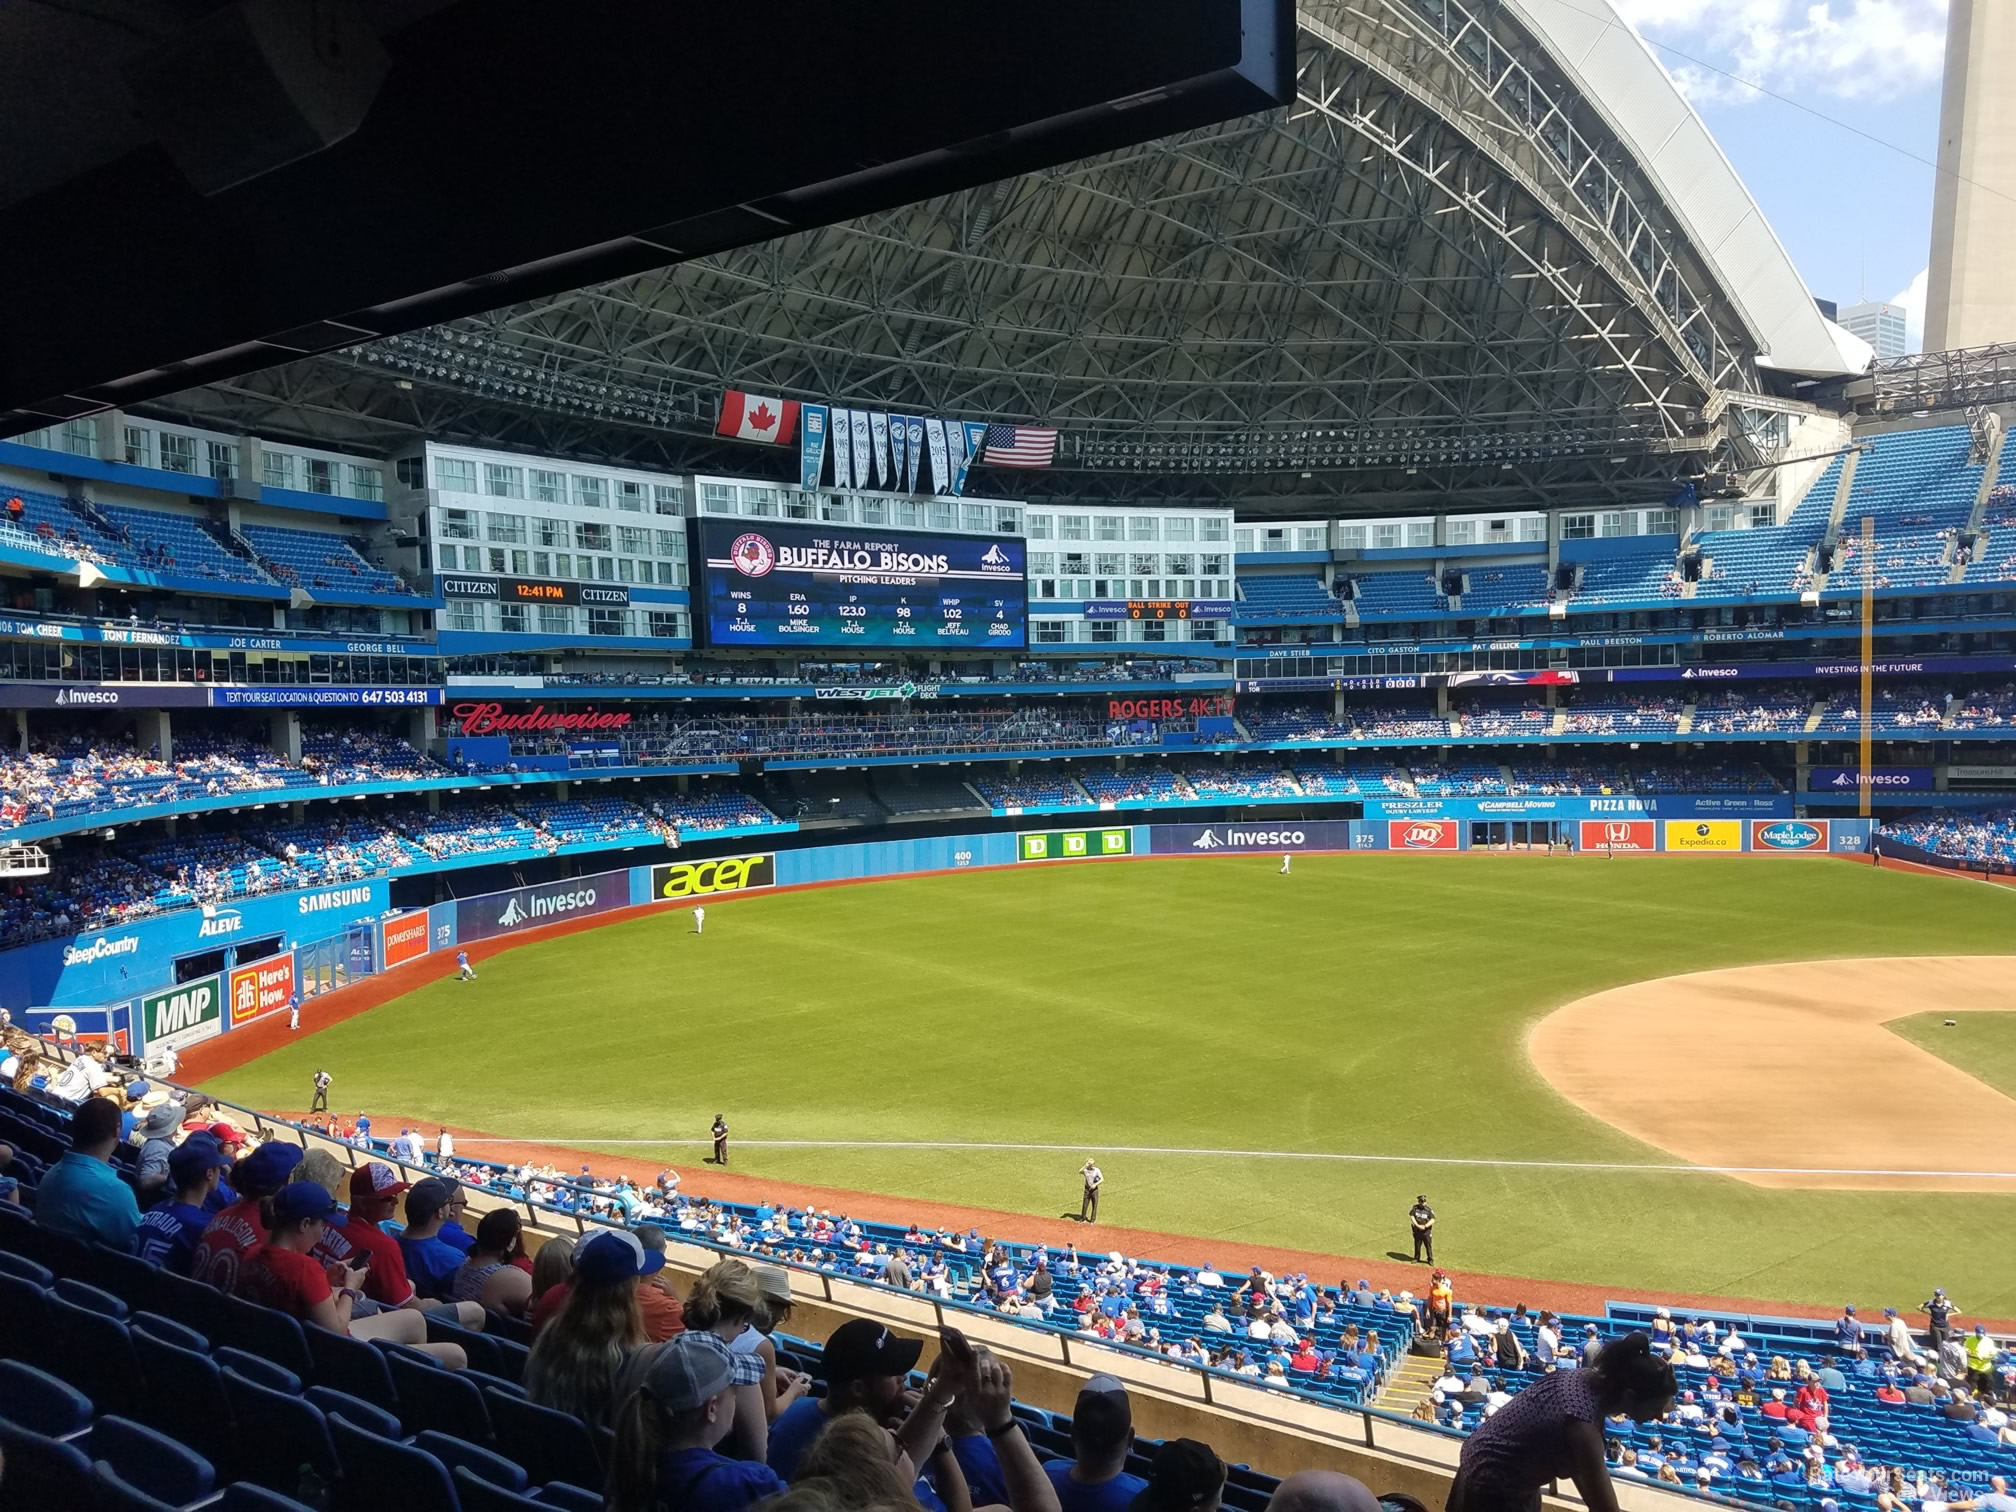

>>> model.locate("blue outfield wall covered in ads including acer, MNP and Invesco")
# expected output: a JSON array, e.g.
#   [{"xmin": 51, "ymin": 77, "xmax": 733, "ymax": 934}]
[{"xmin": 0, "ymin": 818, "xmax": 1871, "ymax": 1050}]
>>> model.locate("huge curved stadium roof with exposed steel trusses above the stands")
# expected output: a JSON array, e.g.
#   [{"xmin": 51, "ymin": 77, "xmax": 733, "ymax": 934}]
[{"xmin": 146, "ymin": 0, "xmax": 1826, "ymax": 514}]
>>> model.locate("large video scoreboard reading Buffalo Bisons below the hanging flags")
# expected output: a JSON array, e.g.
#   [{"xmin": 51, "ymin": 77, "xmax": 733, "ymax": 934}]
[{"xmin": 694, "ymin": 516, "xmax": 1028, "ymax": 651}]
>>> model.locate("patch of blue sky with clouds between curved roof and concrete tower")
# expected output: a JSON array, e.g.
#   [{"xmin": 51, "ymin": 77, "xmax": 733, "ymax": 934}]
[{"xmin": 1615, "ymin": 0, "xmax": 1951, "ymax": 349}]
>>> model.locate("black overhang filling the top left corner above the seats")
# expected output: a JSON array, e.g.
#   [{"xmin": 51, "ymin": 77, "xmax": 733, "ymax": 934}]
[{"xmin": 0, "ymin": 0, "xmax": 1292, "ymax": 433}]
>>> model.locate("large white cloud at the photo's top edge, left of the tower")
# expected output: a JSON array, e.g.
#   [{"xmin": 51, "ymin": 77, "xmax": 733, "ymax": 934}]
[{"xmin": 1615, "ymin": 0, "xmax": 1945, "ymax": 105}]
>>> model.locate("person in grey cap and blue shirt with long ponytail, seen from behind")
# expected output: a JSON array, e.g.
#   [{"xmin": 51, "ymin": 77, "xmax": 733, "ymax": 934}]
[{"xmin": 607, "ymin": 1331, "xmax": 784, "ymax": 1512}]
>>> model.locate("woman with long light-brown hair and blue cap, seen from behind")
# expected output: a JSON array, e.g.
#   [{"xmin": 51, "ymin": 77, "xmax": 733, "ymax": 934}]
[{"xmin": 524, "ymin": 1228, "xmax": 649, "ymax": 1427}]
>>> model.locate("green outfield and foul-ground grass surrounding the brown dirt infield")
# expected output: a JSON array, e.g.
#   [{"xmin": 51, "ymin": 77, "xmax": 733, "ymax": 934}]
[{"xmin": 212, "ymin": 857, "xmax": 2016, "ymax": 1316}]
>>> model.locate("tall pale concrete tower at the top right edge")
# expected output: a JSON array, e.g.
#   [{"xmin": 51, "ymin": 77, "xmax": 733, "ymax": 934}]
[{"xmin": 1925, "ymin": 0, "xmax": 2016, "ymax": 351}]
